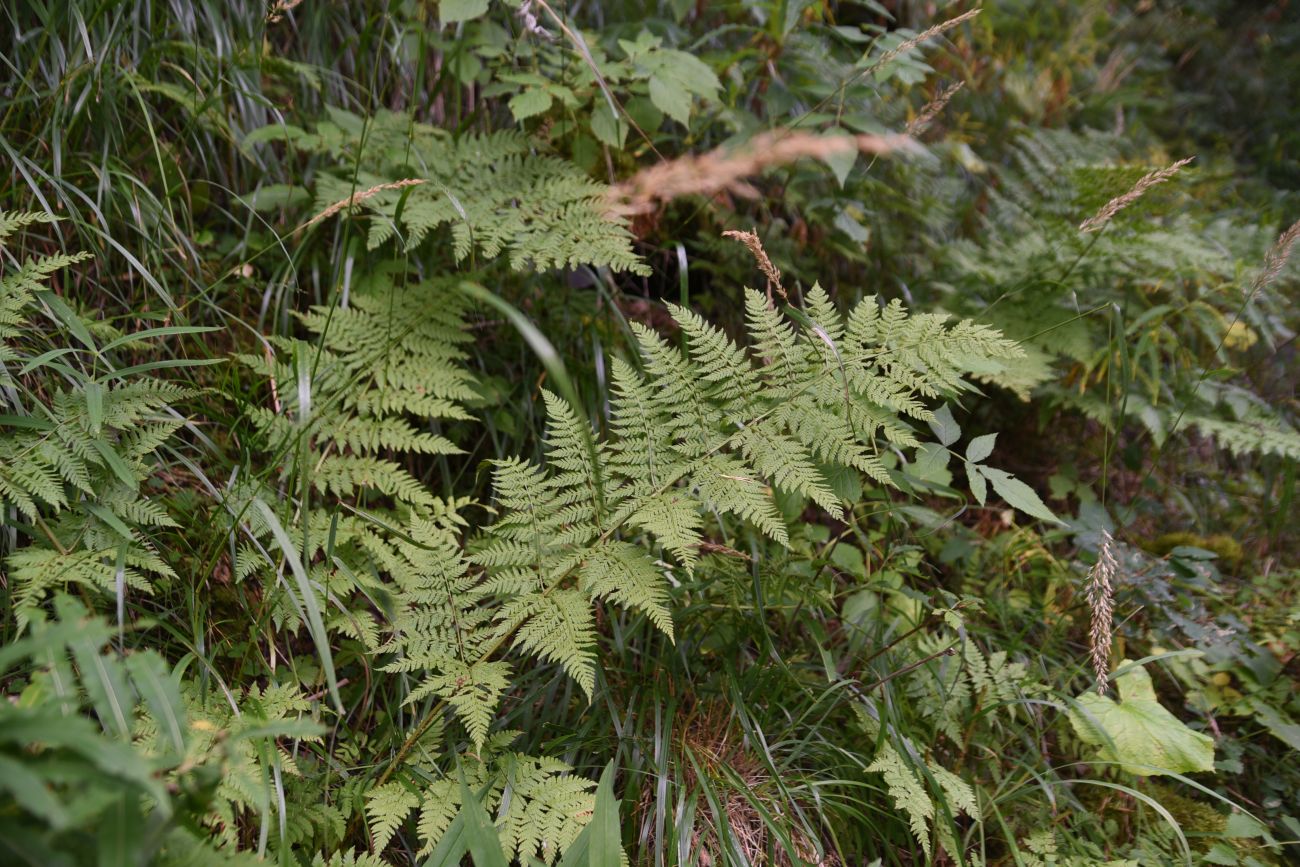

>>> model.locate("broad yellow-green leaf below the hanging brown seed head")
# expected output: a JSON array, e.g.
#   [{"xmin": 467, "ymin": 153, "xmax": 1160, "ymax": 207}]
[{"xmin": 1070, "ymin": 667, "xmax": 1214, "ymax": 776}]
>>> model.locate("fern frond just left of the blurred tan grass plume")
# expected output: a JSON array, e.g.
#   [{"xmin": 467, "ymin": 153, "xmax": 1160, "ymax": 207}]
[{"xmin": 254, "ymin": 108, "xmax": 650, "ymax": 274}]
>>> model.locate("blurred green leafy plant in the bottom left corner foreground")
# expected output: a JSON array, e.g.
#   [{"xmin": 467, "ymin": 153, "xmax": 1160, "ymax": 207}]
[{"xmin": 0, "ymin": 594, "xmax": 247, "ymax": 864}]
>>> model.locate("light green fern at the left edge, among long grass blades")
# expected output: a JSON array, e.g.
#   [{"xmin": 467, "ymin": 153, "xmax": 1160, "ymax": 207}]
[{"xmin": 0, "ymin": 213, "xmax": 191, "ymax": 628}]
